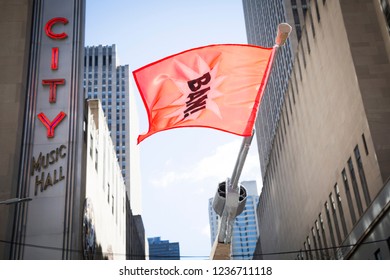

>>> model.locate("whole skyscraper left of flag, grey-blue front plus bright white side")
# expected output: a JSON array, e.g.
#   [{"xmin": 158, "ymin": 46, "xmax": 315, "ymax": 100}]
[{"xmin": 84, "ymin": 45, "xmax": 142, "ymax": 214}]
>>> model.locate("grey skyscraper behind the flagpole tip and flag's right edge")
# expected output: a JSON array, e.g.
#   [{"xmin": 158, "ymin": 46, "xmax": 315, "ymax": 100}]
[{"xmin": 242, "ymin": 0, "xmax": 302, "ymax": 175}]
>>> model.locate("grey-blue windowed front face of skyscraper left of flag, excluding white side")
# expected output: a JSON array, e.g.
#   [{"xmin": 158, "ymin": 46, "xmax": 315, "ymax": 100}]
[{"xmin": 84, "ymin": 45, "xmax": 130, "ymax": 191}]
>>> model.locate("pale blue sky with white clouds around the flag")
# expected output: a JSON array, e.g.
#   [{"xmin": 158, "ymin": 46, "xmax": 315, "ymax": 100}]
[{"xmin": 85, "ymin": 0, "xmax": 262, "ymax": 259}]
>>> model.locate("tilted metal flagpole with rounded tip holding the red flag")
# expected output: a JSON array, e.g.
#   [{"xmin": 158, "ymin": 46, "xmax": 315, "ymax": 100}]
[{"xmin": 210, "ymin": 23, "xmax": 292, "ymax": 260}]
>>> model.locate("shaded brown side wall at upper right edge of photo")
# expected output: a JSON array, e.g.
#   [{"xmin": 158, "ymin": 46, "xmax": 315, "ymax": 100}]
[{"xmin": 340, "ymin": 0, "xmax": 390, "ymax": 181}]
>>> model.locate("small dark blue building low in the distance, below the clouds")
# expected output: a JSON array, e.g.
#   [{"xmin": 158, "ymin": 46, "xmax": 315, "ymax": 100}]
[{"xmin": 148, "ymin": 237, "xmax": 180, "ymax": 260}]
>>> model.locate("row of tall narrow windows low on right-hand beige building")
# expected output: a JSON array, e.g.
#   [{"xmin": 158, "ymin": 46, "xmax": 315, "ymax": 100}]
[{"xmin": 297, "ymin": 140, "xmax": 371, "ymax": 259}]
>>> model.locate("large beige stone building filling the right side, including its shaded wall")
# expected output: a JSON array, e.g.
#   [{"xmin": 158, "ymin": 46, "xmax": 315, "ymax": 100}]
[{"xmin": 258, "ymin": 0, "xmax": 390, "ymax": 259}]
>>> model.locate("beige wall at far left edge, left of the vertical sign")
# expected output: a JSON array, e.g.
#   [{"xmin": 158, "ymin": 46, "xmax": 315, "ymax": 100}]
[{"xmin": 0, "ymin": 0, "xmax": 32, "ymax": 259}]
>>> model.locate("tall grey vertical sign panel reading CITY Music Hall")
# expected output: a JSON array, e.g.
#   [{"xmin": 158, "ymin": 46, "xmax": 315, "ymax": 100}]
[{"xmin": 12, "ymin": 0, "xmax": 85, "ymax": 259}]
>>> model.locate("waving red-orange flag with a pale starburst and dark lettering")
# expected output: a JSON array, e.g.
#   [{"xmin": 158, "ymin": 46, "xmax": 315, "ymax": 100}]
[{"xmin": 133, "ymin": 44, "xmax": 274, "ymax": 143}]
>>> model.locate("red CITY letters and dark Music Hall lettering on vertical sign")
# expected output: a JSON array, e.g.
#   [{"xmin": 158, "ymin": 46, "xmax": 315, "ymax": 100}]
[{"xmin": 31, "ymin": 17, "xmax": 69, "ymax": 196}]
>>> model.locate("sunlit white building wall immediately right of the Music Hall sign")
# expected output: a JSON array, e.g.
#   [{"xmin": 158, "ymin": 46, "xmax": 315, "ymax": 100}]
[{"xmin": 83, "ymin": 99, "xmax": 126, "ymax": 260}]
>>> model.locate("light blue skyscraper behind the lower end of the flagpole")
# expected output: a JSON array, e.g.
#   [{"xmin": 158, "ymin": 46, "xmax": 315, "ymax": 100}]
[{"xmin": 209, "ymin": 181, "xmax": 259, "ymax": 260}]
